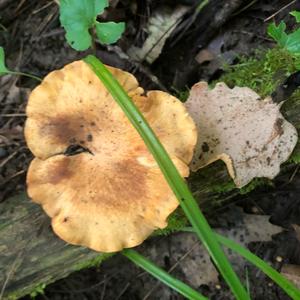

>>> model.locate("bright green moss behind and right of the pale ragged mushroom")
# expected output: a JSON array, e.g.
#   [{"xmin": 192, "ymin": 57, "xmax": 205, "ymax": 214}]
[{"xmin": 218, "ymin": 48, "xmax": 300, "ymax": 164}]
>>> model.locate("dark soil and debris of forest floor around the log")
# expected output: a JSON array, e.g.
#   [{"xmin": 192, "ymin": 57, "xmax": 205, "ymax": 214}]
[{"xmin": 0, "ymin": 0, "xmax": 300, "ymax": 300}]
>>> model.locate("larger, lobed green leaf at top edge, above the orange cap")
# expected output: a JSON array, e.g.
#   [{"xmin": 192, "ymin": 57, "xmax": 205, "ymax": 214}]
[{"xmin": 60, "ymin": 0, "xmax": 108, "ymax": 51}]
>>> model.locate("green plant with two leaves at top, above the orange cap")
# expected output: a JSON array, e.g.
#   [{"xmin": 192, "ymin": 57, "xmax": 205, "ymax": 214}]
[{"xmin": 60, "ymin": 0, "xmax": 125, "ymax": 51}]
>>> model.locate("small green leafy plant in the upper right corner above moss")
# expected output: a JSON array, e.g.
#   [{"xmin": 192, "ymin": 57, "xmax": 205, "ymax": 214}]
[{"xmin": 268, "ymin": 11, "xmax": 300, "ymax": 54}]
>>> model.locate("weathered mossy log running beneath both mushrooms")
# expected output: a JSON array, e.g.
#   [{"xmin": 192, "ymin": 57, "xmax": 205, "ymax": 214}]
[{"xmin": 0, "ymin": 50, "xmax": 300, "ymax": 299}]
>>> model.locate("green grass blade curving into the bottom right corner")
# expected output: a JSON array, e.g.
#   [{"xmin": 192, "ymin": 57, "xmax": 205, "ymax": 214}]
[{"xmin": 182, "ymin": 227, "xmax": 300, "ymax": 300}]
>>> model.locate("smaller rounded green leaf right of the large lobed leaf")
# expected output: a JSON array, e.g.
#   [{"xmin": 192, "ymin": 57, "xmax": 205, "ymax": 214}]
[{"xmin": 96, "ymin": 22, "xmax": 125, "ymax": 44}]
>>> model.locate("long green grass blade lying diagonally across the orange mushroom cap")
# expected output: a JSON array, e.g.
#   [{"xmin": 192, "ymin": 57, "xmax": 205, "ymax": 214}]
[{"xmin": 84, "ymin": 55, "xmax": 250, "ymax": 300}]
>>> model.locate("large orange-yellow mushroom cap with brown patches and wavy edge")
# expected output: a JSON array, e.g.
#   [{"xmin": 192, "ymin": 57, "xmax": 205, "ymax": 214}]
[{"xmin": 25, "ymin": 61, "xmax": 197, "ymax": 252}]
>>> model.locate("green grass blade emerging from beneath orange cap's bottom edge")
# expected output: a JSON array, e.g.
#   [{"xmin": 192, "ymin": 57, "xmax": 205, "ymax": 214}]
[{"xmin": 122, "ymin": 249, "xmax": 207, "ymax": 300}]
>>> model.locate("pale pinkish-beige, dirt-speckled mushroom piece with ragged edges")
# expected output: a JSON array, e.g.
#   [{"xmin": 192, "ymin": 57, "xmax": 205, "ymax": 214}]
[{"xmin": 185, "ymin": 82, "xmax": 298, "ymax": 187}]
